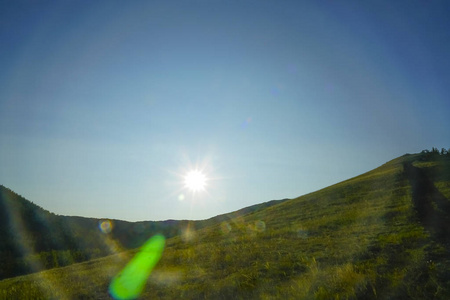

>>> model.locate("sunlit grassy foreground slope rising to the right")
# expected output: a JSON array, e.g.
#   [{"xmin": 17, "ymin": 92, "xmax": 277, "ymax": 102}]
[{"xmin": 0, "ymin": 153, "xmax": 450, "ymax": 299}]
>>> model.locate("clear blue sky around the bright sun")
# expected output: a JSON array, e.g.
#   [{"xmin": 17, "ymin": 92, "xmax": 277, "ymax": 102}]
[{"xmin": 0, "ymin": 0, "xmax": 450, "ymax": 221}]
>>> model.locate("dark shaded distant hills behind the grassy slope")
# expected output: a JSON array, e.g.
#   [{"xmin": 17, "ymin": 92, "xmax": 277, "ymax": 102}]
[{"xmin": 0, "ymin": 185, "xmax": 282, "ymax": 279}]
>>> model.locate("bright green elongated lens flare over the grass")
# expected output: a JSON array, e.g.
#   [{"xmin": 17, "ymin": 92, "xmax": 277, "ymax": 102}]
[{"xmin": 109, "ymin": 235, "xmax": 165, "ymax": 299}]
